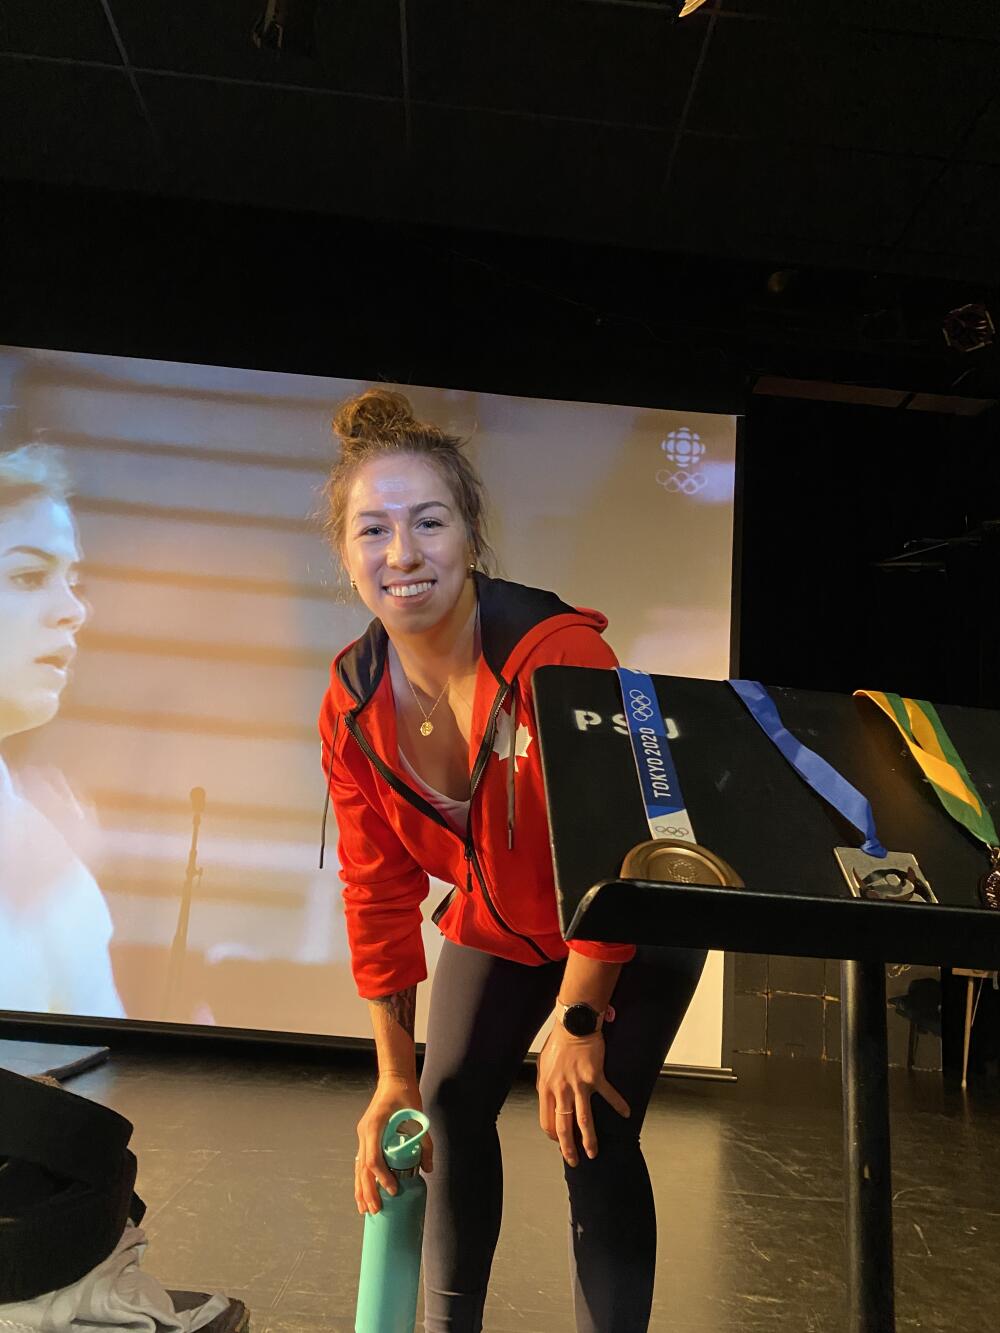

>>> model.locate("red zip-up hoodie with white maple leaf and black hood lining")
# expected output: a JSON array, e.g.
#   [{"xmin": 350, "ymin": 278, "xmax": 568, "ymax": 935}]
[{"xmin": 320, "ymin": 573, "xmax": 635, "ymax": 1000}]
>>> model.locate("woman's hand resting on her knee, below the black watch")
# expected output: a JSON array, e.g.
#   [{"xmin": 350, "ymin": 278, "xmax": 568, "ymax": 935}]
[{"xmin": 537, "ymin": 1025, "xmax": 632, "ymax": 1166}]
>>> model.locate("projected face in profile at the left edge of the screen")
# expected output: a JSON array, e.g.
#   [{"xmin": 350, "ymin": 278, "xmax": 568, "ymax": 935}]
[{"xmin": 0, "ymin": 496, "xmax": 87, "ymax": 738}]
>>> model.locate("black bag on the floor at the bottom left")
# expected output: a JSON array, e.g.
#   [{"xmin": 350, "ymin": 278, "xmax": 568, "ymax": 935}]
[{"xmin": 0, "ymin": 1069, "xmax": 145, "ymax": 1305}]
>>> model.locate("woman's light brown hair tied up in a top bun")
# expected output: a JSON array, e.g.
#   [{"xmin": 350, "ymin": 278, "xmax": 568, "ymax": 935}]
[{"xmin": 323, "ymin": 388, "xmax": 493, "ymax": 565}]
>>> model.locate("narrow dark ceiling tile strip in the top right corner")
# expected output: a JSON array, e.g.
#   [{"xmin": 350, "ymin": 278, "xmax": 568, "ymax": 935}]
[{"xmin": 716, "ymin": 0, "xmax": 1000, "ymax": 43}]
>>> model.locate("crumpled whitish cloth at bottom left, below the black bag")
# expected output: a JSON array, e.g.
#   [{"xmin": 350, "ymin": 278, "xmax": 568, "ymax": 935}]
[{"xmin": 0, "ymin": 1225, "xmax": 229, "ymax": 1333}]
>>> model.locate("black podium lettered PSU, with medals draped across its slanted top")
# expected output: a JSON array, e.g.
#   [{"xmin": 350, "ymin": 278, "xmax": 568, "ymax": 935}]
[{"xmin": 533, "ymin": 667, "xmax": 1000, "ymax": 1333}]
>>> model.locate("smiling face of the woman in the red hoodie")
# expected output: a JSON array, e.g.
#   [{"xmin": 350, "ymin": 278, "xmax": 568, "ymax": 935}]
[{"xmin": 341, "ymin": 453, "xmax": 475, "ymax": 636}]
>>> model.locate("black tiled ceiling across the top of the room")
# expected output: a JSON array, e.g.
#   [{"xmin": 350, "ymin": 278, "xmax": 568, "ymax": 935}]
[{"xmin": 0, "ymin": 0, "xmax": 1000, "ymax": 283}]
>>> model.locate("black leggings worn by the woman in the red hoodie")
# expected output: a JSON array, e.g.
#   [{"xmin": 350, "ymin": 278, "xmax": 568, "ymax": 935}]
[{"xmin": 420, "ymin": 941, "xmax": 705, "ymax": 1333}]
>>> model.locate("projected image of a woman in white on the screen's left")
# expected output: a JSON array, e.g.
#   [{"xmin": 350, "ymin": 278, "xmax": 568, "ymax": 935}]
[{"xmin": 0, "ymin": 447, "xmax": 124, "ymax": 1017}]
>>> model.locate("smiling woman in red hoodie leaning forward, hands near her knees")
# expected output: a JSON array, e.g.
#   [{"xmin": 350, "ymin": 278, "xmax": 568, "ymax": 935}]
[{"xmin": 320, "ymin": 389, "xmax": 704, "ymax": 1333}]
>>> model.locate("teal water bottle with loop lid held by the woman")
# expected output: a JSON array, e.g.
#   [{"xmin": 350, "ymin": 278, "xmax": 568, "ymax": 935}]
[{"xmin": 355, "ymin": 1110, "xmax": 431, "ymax": 1333}]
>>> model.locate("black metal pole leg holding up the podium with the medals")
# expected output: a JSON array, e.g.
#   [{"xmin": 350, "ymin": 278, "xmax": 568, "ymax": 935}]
[{"xmin": 840, "ymin": 961, "xmax": 896, "ymax": 1333}]
